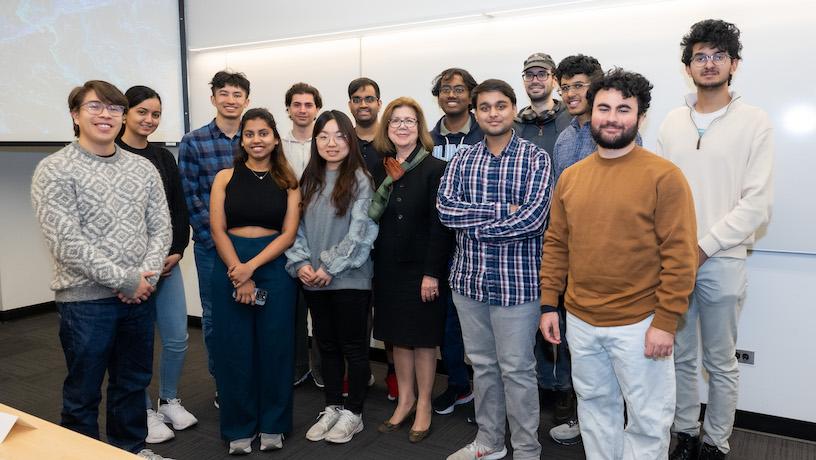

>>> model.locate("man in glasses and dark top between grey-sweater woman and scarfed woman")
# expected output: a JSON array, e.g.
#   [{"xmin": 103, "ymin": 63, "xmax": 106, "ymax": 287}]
[{"xmin": 348, "ymin": 77, "xmax": 382, "ymax": 172}]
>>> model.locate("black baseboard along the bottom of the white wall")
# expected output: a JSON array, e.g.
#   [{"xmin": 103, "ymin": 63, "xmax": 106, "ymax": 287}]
[{"xmin": 0, "ymin": 302, "xmax": 816, "ymax": 442}]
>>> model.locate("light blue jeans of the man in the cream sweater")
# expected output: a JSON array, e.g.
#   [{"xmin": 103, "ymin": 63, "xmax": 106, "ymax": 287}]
[{"xmin": 673, "ymin": 257, "xmax": 748, "ymax": 453}]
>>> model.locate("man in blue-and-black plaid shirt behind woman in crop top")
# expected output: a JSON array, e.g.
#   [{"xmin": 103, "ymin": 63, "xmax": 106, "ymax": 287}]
[{"xmin": 179, "ymin": 70, "xmax": 249, "ymax": 407}]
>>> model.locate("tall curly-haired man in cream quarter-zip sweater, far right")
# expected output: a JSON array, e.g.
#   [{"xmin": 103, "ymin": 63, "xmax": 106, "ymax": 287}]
[{"xmin": 657, "ymin": 19, "xmax": 774, "ymax": 460}]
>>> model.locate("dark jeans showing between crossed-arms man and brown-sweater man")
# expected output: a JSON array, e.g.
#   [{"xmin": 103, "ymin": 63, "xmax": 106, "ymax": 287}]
[{"xmin": 535, "ymin": 308, "xmax": 572, "ymax": 391}]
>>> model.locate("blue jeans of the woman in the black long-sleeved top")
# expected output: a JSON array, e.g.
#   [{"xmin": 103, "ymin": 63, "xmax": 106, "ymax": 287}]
[{"xmin": 145, "ymin": 264, "xmax": 187, "ymax": 407}]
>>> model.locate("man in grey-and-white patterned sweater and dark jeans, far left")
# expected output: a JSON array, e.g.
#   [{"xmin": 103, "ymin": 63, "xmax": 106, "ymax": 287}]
[{"xmin": 31, "ymin": 80, "xmax": 171, "ymax": 455}]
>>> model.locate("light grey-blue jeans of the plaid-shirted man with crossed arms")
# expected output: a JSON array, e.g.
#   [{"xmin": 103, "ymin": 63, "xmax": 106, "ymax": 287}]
[{"xmin": 452, "ymin": 292, "xmax": 541, "ymax": 460}]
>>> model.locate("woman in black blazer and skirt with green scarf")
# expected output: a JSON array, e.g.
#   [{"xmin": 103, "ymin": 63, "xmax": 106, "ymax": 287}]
[{"xmin": 369, "ymin": 97, "xmax": 453, "ymax": 442}]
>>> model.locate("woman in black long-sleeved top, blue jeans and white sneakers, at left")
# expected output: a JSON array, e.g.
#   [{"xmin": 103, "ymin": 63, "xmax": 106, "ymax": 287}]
[{"xmin": 116, "ymin": 86, "xmax": 198, "ymax": 444}]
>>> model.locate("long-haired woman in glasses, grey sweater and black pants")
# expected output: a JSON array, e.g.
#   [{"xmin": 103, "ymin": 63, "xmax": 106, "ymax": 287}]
[{"xmin": 286, "ymin": 110, "xmax": 377, "ymax": 443}]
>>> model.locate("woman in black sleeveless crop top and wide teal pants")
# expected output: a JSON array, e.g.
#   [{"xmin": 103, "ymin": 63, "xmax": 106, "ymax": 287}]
[{"xmin": 210, "ymin": 109, "xmax": 300, "ymax": 454}]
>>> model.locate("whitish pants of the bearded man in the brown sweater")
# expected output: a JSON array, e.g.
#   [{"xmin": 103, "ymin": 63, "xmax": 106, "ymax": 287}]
[{"xmin": 567, "ymin": 313, "xmax": 675, "ymax": 460}]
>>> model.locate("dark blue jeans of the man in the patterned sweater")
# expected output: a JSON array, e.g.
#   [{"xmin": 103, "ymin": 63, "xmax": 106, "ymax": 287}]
[{"xmin": 57, "ymin": 297, "xmax": 155, "ymax": 452}]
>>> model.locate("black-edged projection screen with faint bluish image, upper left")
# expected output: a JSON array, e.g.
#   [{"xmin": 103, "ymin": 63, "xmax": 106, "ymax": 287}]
[{"xmin": 0, "ymin": 0, "xmax": 184, "ymax": 142}]
